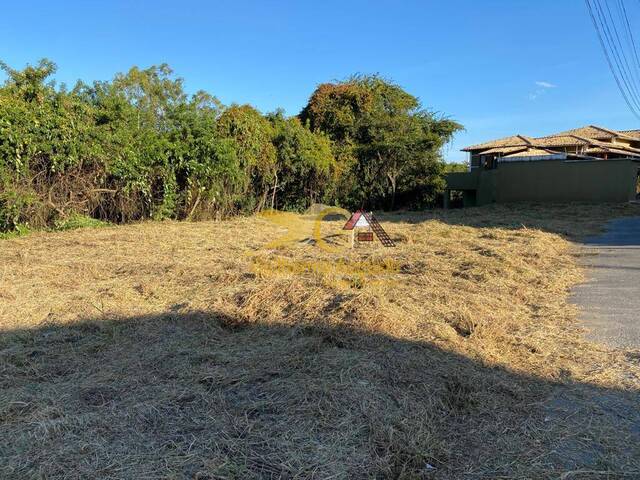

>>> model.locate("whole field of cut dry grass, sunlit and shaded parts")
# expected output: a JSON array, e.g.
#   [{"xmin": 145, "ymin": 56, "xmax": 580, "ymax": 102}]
[{"xmin": 0, "ymin": 205, "xmax": 640, "ymax": 480}]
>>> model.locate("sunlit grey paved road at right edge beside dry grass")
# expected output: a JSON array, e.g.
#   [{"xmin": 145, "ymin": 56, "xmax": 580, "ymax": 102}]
[{"xmin": 573, "ymin": 217, "xmax": 640, "ymax": 348}]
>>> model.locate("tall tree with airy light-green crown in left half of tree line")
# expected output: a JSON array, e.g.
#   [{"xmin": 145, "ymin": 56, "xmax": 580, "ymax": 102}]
[{"xmin": 82, "ymin": 65, "xmax": 186, "ymax": 221}]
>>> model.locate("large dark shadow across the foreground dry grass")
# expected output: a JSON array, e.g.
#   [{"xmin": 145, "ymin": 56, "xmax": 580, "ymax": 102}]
[{"xmin": 0, "ymin": 305, "xmax": 640, "ymax": 479}]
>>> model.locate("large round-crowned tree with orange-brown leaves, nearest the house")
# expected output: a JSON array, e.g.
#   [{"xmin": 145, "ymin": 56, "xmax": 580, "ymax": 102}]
[{"xmin": 300, "ymin": 76, "xmax": 462, "ymax": 208}]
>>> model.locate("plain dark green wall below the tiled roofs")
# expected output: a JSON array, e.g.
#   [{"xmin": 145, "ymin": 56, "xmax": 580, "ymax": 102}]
[{"xmin": 445, "ymin": 159, "xmax": 640, "ymax": 206}]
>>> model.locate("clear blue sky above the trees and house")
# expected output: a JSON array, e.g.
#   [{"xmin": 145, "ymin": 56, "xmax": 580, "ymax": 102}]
[{"xmin": 0, "ymin": 0, "xmax": 640, "ymax": 161}]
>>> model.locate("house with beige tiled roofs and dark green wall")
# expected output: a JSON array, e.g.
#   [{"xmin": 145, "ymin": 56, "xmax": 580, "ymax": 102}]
[{"xmin": 445, "ymin": 125, "xmax": 640, "ymax": 206}]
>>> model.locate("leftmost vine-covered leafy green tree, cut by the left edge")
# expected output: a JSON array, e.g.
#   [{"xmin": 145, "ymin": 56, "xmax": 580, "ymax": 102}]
[{"xmin": 0, "ymin": 60, "xmax": 101, "ymax": 230}]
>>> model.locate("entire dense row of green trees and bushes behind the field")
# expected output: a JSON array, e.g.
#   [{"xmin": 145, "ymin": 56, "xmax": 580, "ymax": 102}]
[{"xmin": 0, "ymin": 60, "xmax": 461, "ymax": 231}]
